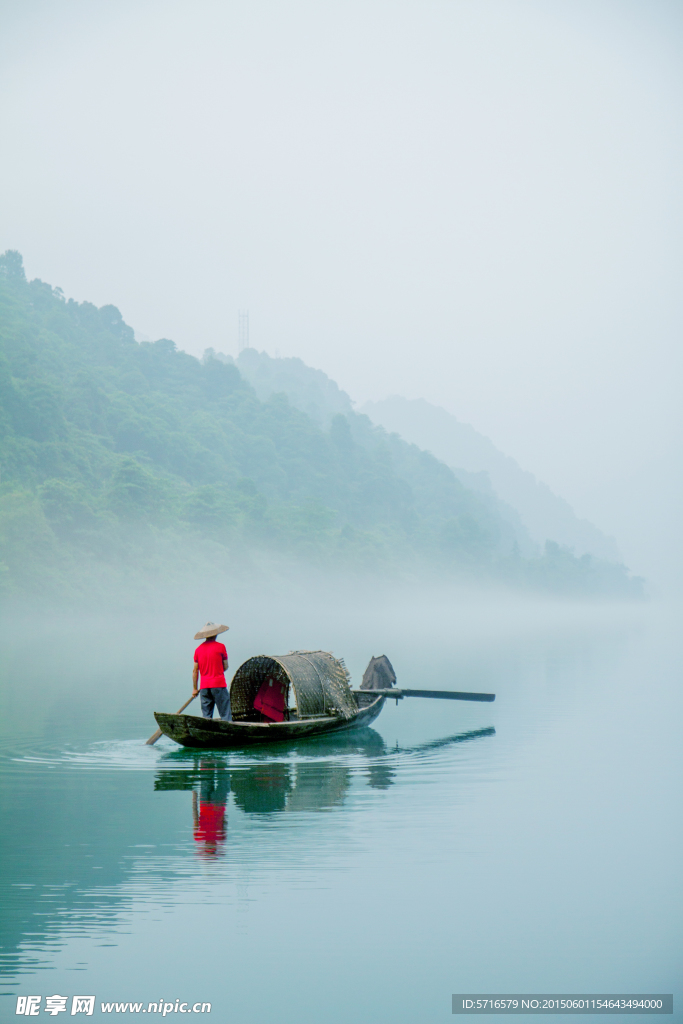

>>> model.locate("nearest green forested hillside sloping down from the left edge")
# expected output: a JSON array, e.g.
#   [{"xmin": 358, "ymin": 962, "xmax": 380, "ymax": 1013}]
[{"xmin": 0, "ymin": 252, "xmax": 640, "ymax": 596}]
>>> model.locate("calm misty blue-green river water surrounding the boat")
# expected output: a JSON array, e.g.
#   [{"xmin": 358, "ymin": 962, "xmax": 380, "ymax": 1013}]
[{"xmin": 0, "ymin": 601, "xmax": 683, "ymax": 1024}]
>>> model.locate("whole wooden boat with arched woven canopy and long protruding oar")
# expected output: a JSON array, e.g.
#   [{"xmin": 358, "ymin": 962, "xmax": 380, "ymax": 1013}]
[{"xmin": 151, "ymin": 650, "xmax": 495, "ymax": 750}]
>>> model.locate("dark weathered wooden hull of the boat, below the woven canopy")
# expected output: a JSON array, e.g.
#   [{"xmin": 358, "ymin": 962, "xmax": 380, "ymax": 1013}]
[{"xmin": 155, "ymin": 696, "xmax": 386, "ymax": 751}]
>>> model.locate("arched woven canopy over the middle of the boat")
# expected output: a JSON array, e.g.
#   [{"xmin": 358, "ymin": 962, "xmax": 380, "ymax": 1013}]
[{"xmin": 230, "ymin": 650, "xmax": 358, "ymax": 722}]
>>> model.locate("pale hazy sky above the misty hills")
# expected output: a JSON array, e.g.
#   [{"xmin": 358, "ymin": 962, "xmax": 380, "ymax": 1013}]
[{"xmin": 0, "ymin": 0, "xmax": 683, "ymax": 589}]
